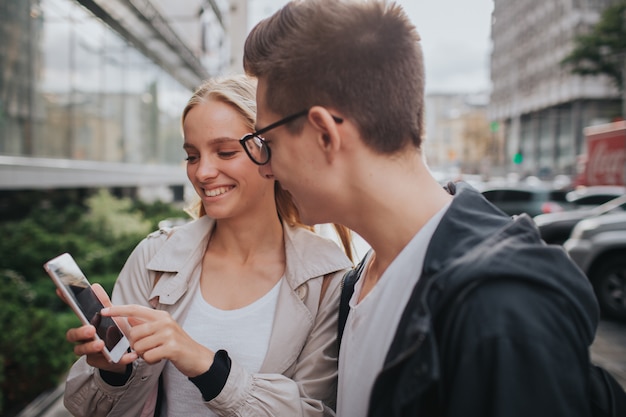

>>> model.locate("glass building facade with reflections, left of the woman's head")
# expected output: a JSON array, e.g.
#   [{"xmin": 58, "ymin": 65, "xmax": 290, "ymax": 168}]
[{"xmin": 0, "ymin": 0, "xmax": 195, "ymax": 164}]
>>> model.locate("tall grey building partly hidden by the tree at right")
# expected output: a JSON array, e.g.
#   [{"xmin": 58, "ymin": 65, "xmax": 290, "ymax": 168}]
[{"xmin": 489, "ymin": 0, "xmax": 621, "ymax": 176}]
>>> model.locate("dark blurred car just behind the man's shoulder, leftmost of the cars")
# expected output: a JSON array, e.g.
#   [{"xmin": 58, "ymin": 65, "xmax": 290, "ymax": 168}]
[{"xmin": 482, "ymin": 185, "xmax": 567, "ymax": 217}]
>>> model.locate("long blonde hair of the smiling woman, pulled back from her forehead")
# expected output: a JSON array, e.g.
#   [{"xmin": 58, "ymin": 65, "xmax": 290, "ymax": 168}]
[{"xmin": 181, "ymin": 74, "xmax": 353, "ymax": 260}]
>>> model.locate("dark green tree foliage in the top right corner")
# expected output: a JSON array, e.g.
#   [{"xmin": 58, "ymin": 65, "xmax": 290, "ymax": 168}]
[{"xmin": 562, "ymin": 0, "xmax": 626, "ymax": 89}]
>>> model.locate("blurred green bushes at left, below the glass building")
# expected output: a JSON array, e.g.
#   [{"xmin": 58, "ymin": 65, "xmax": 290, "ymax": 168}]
[{"xmin": 0, "ymin": 192, "xmax": 186, "ymax": 416}]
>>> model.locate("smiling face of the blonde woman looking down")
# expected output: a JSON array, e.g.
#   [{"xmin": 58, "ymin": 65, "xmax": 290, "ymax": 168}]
[{"xmin": 183, "ymin": 99, "xmax": 276, "ymax": 219}]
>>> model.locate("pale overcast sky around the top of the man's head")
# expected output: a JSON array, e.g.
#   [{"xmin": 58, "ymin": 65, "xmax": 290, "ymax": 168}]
[{"xmin": 250, "ymin": 0, "xmax": 494, "ymax": 93}]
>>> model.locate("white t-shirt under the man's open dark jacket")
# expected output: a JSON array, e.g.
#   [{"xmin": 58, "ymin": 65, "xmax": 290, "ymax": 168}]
[{"xmin": 337, "ymin": 205, "xmax": 449, "ymax": 417}]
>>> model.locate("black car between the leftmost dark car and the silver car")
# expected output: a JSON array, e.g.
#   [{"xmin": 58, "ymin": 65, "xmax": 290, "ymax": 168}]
[{"xmin": 533, "ymin": 195, "xmax": 626, "ymax": 245}]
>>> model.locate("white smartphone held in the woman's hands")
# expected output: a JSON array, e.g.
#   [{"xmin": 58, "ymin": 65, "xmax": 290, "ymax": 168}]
[{"xmin": 44, "ymin": 253, "xmax": 130, "ymax": 363}]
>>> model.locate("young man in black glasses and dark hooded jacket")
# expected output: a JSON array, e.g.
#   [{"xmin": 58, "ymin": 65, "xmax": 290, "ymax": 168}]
[{"xmin": 241, "ymin": 0, "xmax": 598, "ymax": 417}]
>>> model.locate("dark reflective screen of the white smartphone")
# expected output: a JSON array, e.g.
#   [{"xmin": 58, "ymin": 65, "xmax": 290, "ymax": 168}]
[{"xmin": 47, "ymin": 258, "xmax": 123, "ymax": 351}]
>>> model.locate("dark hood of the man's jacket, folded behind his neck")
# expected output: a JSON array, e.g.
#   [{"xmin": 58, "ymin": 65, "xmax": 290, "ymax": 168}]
[{"xmin": 386, "ymin": 183, "xmax": 594, "ymax": 366}]
